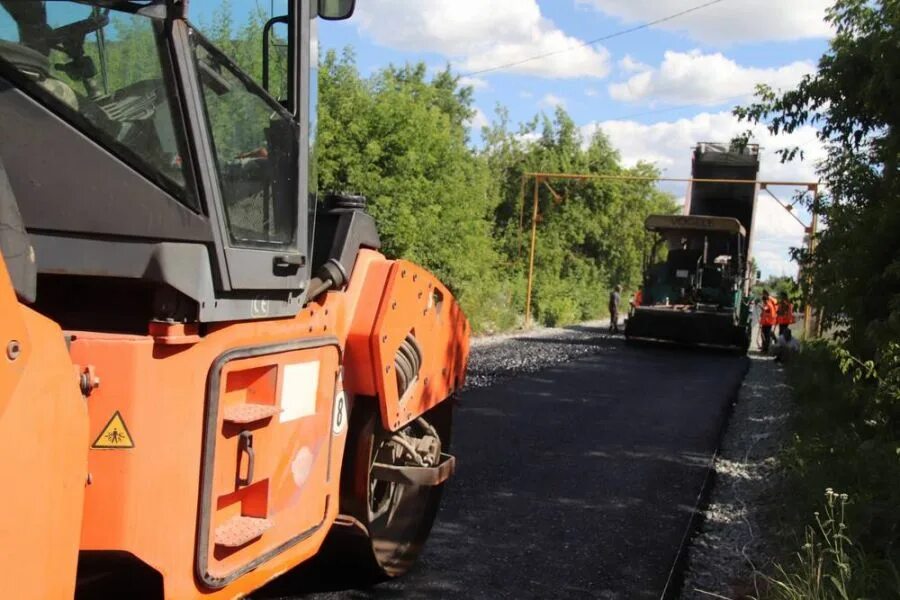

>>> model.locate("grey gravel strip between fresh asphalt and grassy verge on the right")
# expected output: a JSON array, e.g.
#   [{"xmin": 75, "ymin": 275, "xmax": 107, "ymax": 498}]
[{"xmin": 681, "ymin": 354, "xmax": 791, "ymax": 600}]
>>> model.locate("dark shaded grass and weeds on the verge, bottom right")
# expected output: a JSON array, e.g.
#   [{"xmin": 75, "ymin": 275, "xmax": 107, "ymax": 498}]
[{"xmin": 761, "ymin": 342, "xmax": 900, "ymax": 600}]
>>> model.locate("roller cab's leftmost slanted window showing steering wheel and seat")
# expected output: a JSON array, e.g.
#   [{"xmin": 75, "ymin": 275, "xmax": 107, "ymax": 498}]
[{"xmin": 0, "ymin": 0, "xmax": 199, "ymax": 210}]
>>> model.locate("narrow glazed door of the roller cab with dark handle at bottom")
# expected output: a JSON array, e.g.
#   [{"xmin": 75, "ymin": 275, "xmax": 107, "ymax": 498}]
[{"xmin": 173, "ymin": 3, "xmax": 309, "ymax": 292}]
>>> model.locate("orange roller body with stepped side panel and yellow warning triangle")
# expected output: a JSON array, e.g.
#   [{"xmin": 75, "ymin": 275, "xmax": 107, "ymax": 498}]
[{"xmin": 65, "ymin": 251, "xmax": 468, "ymax": 598}]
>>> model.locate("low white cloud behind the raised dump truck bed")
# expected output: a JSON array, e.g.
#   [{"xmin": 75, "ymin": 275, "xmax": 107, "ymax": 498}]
[{"xmin": 582, "ymin": 112, "xmax": 825, "ymax": 275}]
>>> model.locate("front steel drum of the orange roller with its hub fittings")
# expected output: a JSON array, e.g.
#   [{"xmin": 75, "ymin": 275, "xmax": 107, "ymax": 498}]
[{"xmin": 341, "ymin": 401, "xmax": 452, "ymax": 581}]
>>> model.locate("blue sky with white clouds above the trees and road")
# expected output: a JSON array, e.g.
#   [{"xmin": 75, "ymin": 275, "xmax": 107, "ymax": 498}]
[{"xmin": 192, "ymin": 0, "xmax": 830, "ymax": 276}]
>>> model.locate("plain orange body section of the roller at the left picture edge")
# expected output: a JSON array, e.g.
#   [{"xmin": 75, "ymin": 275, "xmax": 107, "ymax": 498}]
[{"xmin": 0, "ymin": 259, "xmax": 88, "ymax": 600}]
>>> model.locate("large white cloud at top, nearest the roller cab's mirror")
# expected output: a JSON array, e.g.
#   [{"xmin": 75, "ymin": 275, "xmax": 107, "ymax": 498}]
[{"xmin": 355, "ymin": 0, "xmax": 610, "ymax": 79}]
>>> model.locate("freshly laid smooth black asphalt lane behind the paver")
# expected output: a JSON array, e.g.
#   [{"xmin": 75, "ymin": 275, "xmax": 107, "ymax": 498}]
[{"xmin": 253, "ymin": 329, "xmax": 747, "ymax": 599}]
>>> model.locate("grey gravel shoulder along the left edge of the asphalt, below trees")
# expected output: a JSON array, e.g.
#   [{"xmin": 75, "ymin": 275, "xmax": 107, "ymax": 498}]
[{"xmin": 466, "ymin": 320, "xmax": 622, "ymax": 389}]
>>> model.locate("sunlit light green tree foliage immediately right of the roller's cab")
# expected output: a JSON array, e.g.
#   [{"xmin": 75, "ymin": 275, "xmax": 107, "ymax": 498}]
[{"xmin": 315, "ymin": 50, "xmax": 514, "ymax": 330}]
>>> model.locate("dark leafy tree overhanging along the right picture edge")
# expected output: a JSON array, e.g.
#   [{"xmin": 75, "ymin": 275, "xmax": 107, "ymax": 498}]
[{"xmin": 736, "ymin": 0, "xmax": 900, "ymax": 357}]
